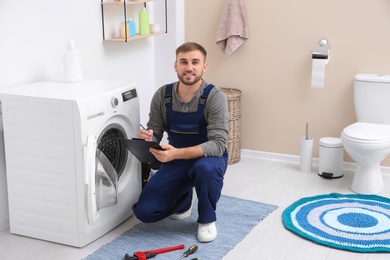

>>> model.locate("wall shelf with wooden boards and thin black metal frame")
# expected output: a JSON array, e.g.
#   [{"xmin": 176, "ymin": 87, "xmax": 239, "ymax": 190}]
[{"xmin": 101, "ymin": 0, "xmax": 168, "ymax": 42}]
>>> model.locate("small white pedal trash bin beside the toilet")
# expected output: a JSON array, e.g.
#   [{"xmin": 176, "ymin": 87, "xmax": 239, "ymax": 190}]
[{"xmin": 318, "ymin": 137, "xmax": 344, "ymax": 179}]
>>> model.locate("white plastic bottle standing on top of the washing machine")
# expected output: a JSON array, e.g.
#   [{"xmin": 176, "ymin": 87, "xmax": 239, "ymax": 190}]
[{"xmin": 63, "ymin": 41, "xmax": 83, "ymax": 83}]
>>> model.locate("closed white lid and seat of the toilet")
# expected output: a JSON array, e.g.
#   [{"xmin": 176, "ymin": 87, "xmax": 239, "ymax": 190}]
[{"xmin": 343, "ymin": 122, "xmax": 390, "ymax": 141}]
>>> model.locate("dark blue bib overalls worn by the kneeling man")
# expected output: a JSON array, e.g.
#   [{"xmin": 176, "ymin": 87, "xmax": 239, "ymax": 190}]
[{"xmin": 133, "ymin": 84, "xmax": 228, "ymax": 224}]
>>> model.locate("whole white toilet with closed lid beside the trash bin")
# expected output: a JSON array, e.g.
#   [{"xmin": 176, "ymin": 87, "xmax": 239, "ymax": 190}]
[{"xmin": 340, "ymin": 74, "xmax": 390, "ymax": 194}]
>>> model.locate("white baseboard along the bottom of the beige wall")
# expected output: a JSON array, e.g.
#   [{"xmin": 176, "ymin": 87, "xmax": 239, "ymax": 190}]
[{"xmin": 241, "ymin": 149, "xmax": 390, "ymax": 174}]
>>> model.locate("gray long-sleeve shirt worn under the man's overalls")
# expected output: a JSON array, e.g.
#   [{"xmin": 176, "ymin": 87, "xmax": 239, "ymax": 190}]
[{"xmin": 148, "ymin": 80, "xmax": 229, "ymax": 156}]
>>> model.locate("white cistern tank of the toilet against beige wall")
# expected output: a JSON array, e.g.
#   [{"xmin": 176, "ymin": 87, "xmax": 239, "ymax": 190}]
[{"xmin": 354, "ymin": 74, "xmax": 390, "ymax": 125}]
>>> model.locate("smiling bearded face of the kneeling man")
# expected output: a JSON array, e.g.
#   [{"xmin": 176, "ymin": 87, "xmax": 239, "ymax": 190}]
[{"xmin": 175, "ymin": 50, "xmax": 207, "ymax": 85}]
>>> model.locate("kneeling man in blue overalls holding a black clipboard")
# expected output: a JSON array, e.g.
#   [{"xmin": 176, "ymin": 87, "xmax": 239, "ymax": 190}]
[{"xmin": 133, "ymin": 42, "xmax": 229, "ymax": 242}]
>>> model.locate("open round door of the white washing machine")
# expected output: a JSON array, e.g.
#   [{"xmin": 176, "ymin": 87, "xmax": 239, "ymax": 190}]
[{"xmin": 85, "ymin": 135, "xmax": 118, "ymax": 224}]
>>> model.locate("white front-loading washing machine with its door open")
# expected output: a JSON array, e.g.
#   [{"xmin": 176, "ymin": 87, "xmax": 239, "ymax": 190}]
[{"xmin": 0, "ymin": 81, "xmax": 142, "ymax": 247}]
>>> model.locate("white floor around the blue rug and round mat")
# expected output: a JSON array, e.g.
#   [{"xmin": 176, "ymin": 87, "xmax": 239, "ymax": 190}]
[{"xmin": 0, "ymin": 154, "xmax": 390, "ymax": 260}]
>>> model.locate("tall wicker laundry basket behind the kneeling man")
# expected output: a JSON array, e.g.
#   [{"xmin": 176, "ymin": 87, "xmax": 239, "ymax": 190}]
[{"xmin": 221, "ymin": 88, "xmax": 241, "ymax": 164}]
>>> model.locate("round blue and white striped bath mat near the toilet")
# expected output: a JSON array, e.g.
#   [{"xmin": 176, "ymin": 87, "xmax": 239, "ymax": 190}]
[{"xmin": 282, "ymin": 193, "xmax": 390, "ymax": 253}]
